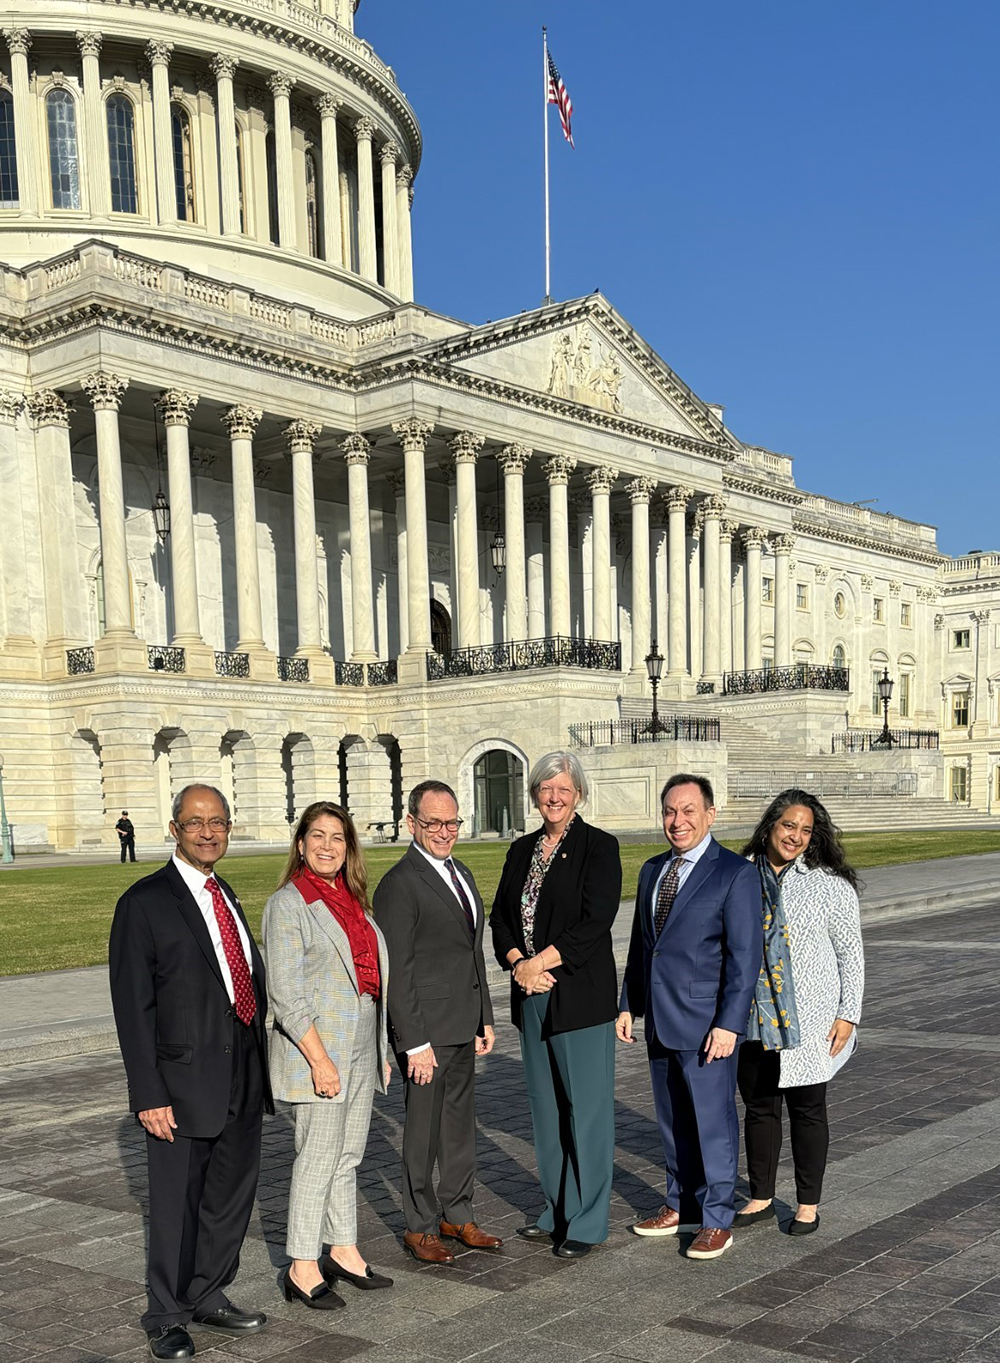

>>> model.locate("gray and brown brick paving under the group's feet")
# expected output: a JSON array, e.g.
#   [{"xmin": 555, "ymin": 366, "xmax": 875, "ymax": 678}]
[{"xmin": 0, "ymin": 906, "xmax": 1000, "ymax": 1363}]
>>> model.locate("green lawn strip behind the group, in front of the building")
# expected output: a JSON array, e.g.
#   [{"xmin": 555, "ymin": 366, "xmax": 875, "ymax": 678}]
[{"xmin": 0, "ymin": 830, "xmax": 1000, "ymax": 975}]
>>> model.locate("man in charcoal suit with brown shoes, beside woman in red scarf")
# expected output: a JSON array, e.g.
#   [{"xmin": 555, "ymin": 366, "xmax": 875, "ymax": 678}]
[{"xmin": 372, "ymin": 781, "xmax": 501, "ymax": 1264}]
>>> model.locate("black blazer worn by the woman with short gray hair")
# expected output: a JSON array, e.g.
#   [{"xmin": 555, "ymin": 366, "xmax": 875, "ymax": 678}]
[{"xmin": 489, "ymin": 814, "xmax": 621, "ymax": 1036}]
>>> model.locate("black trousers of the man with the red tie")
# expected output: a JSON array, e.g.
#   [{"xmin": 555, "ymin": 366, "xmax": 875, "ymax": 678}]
[{"xmin": 142, "ymin": 1018, "xmax": 264, "ymax": 1330}]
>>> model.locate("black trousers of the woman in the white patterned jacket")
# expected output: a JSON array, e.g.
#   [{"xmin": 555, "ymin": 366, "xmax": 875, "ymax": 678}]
[{"xmin": 736, "ymin": 1041, "xmax": 830, "ymax": 1206}]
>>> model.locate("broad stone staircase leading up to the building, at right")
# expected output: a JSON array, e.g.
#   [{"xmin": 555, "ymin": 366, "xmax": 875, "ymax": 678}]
[{"xmin": 620, "ymin": 696, "xmax": 986, "ymax": 834}]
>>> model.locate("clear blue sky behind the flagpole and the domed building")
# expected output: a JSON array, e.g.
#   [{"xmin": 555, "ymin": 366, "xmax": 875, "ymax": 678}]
[{"xmin": 357, "ymin": 0, "xmax": 1000, "ymax": 553}]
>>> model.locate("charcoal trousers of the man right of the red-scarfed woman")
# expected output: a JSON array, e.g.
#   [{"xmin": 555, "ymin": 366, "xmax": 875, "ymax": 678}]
[{"xmin": 396, "ymin": 1039, "xmax": 475, "ymax": 1235}]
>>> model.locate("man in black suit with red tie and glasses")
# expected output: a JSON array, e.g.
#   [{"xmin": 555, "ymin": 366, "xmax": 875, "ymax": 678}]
[{"xmin": 108, "ymin": 785, "xmax": 274, "ymax": 1359}]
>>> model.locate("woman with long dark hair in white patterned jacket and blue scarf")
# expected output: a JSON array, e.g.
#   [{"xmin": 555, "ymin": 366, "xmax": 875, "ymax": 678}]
[{"xmin": 734, "ymin": 789, "xmax": 865, "ymax": 1235}]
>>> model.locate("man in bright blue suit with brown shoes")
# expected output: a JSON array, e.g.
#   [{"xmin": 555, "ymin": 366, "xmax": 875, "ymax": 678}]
[{"xmin": 616, "ymin": 773, "xmax": 763, "ymax": 1259}]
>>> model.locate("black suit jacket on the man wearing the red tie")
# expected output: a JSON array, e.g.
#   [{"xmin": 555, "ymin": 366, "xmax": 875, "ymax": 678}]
[{"xmin": 108, "ymin": 860, "xmax": 274, "ymax": 1137}]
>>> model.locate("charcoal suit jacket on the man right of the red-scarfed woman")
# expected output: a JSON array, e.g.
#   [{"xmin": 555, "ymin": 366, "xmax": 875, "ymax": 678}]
[{"xmin": 372, "ymin": 846, "xmax": 493, "ymax": 1051}]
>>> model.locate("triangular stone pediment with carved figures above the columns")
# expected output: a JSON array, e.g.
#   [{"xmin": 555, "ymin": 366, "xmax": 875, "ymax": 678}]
[{"xmin": 411, "ymin": 294, "xmax": 741, "ymax": 454}]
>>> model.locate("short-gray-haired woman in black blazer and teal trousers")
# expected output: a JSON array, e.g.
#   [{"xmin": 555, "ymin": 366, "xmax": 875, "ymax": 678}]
[{"xmin": 489, "ymin": 752, "xmax": 621, "ymax": 1259}]
